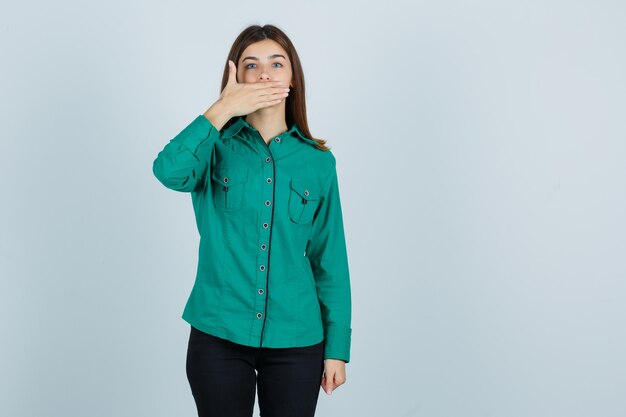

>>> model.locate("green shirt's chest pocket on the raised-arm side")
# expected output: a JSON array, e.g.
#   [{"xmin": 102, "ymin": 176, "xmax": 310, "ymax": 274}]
[{"xmin": 211, "ymin": 165, "xmax": 248, "ymax": 211}]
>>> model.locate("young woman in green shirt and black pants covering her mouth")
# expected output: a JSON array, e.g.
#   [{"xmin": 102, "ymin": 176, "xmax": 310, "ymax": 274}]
[{"xmin": 153, "ymin": 25, "xmax": 352, "ymax": 417}]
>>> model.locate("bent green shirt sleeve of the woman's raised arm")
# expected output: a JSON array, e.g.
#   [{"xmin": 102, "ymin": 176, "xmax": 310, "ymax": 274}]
[{"xmin": 152, "ymin": 115, "xmax": 220, "ymax": 192}]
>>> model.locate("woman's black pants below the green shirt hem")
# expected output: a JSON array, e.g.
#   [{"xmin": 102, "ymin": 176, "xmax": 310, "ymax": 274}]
[{"xmin": 186, "ymin": 326, "xmax": 324, "ymax": 417}]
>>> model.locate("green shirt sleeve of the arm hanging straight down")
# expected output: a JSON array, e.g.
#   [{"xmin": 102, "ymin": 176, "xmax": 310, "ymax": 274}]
[{"xmin": 306, "ymin": 161, "xmax": 352, "ymax": 363}]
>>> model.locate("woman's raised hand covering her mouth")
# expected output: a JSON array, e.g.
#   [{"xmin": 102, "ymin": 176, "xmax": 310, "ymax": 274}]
[{"xmin": 218, "ymin": 59, "xmax": 289, "ymax": 117}]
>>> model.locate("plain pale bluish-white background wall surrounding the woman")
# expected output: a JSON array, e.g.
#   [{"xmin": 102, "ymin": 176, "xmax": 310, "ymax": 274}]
[{"xmin": 0, "ymin": 0, "xmax": 626, "ymax": 417}]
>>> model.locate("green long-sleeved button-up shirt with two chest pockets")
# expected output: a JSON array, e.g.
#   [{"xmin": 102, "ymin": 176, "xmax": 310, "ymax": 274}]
[{"xmin": 153, "ymin": 115, "xmax": 352, "ymax": 362}]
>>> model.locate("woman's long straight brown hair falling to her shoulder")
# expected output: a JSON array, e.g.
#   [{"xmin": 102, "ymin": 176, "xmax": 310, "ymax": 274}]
[{"xmin": 220, "ymin": 25, "xmax": 330, "ymax": 151}]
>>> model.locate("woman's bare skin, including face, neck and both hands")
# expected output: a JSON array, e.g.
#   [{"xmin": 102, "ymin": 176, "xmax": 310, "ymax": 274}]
[{"xmin": 204, "ymin": 39, "xmax": 346, "ymax": 395}]
